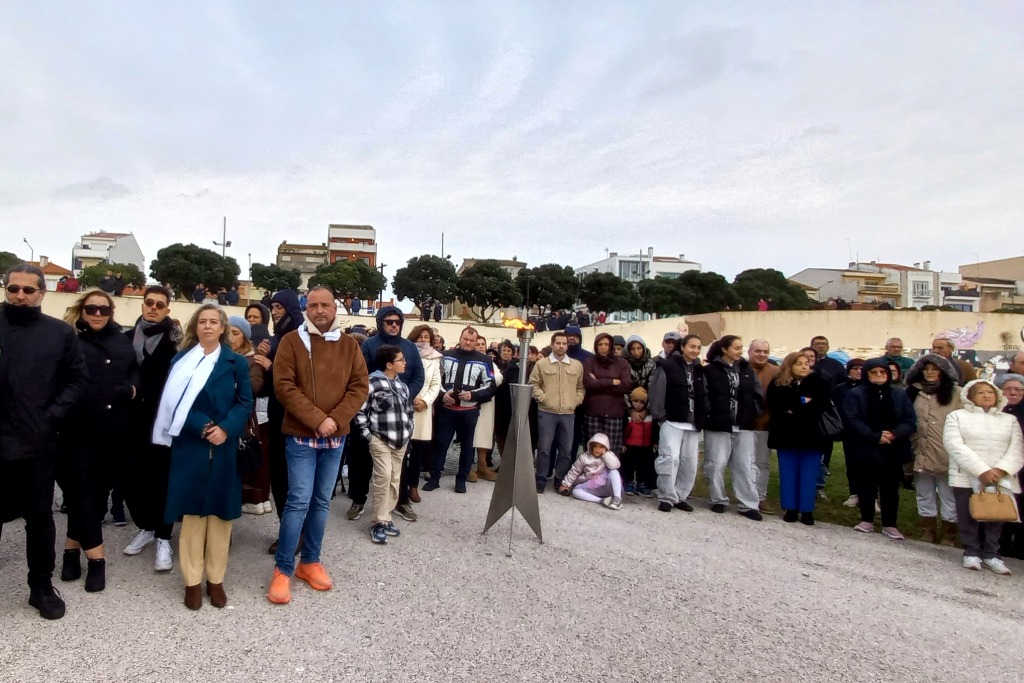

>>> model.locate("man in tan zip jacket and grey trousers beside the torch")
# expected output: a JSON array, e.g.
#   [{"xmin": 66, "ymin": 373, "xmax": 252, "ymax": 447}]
[{"xmin": 529, "ymin": 332, "xmax": 584, "ymax": 494}]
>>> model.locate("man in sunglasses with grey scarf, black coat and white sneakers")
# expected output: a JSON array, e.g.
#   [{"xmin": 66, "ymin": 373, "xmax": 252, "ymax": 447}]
[{"xmin": 122, "ymin": 285, "xmax": 180, "ymax": 571}]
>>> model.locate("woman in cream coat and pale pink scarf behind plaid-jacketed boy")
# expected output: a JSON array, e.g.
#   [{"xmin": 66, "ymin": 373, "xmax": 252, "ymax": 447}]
[{"xmin": 395, "ymin": 325, "xmax": 441, "ymax": 507}]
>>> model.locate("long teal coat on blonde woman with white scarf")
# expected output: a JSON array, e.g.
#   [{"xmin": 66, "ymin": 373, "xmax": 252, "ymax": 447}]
[{"xmin": 164, "ymin": 344, "xmax": 253, "ymax": 523}]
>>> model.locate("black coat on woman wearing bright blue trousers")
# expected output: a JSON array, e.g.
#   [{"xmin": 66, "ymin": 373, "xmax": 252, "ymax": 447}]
[{"xmin": 767, "ymin": 374, "xmax": 831, "ymax": 452}]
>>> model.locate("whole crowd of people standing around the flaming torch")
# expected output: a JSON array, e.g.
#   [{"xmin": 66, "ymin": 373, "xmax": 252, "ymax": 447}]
[{"xmin": 0, "ymin": 264, "xmax": 1024, "ymax": 618}]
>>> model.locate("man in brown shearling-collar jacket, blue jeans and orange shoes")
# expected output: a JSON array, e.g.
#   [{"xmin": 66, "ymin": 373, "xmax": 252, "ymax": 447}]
[{"xmin": 267, "ymin": 287, "xmax": 370, "ymax": 604}]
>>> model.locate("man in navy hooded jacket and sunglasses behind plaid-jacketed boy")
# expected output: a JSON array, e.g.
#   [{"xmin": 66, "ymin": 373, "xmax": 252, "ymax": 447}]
[{"xmin": 346, "ymin": 306, "xmax": 424, "ymax": 521}]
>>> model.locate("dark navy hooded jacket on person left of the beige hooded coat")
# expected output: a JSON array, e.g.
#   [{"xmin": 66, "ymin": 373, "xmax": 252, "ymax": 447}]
[{"xmin": 840, "ymin": 358, "xmax": 918, "ymax": 463}]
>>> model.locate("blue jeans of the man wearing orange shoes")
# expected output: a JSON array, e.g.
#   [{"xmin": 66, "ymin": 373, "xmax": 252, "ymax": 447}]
[{"xmin": 273, "ymin": 436, "xmax": 345, "ymax": 577}]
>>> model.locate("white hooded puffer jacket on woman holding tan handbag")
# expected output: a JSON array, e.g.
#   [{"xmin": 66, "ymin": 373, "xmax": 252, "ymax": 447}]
[{"xmin": 942, "ymin": 380, "xmax": 1024, "ymax": 494}]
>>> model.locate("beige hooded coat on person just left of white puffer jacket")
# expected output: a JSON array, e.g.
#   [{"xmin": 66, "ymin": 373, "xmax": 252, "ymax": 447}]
[{"xmin": 905, "ymin": 353, "xmax": 961, "ymax": 476}]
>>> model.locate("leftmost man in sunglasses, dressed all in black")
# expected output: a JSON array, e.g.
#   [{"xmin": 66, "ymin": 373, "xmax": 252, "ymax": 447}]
[{"xmin": 0, "ymin": 263, "xmax": 89, "ymax": 620}]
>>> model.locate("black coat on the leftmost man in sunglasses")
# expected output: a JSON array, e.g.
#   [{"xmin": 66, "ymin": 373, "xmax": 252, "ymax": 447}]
[{"xmin": 0, "ymin": 303, "xmax": 89, "ymax": 461}]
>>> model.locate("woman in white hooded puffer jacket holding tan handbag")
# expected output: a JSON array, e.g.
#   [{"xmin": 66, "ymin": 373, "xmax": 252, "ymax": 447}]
[{"xmin": 942, "ymin": 380, "xmax": 1024, "ymax": 574}]
